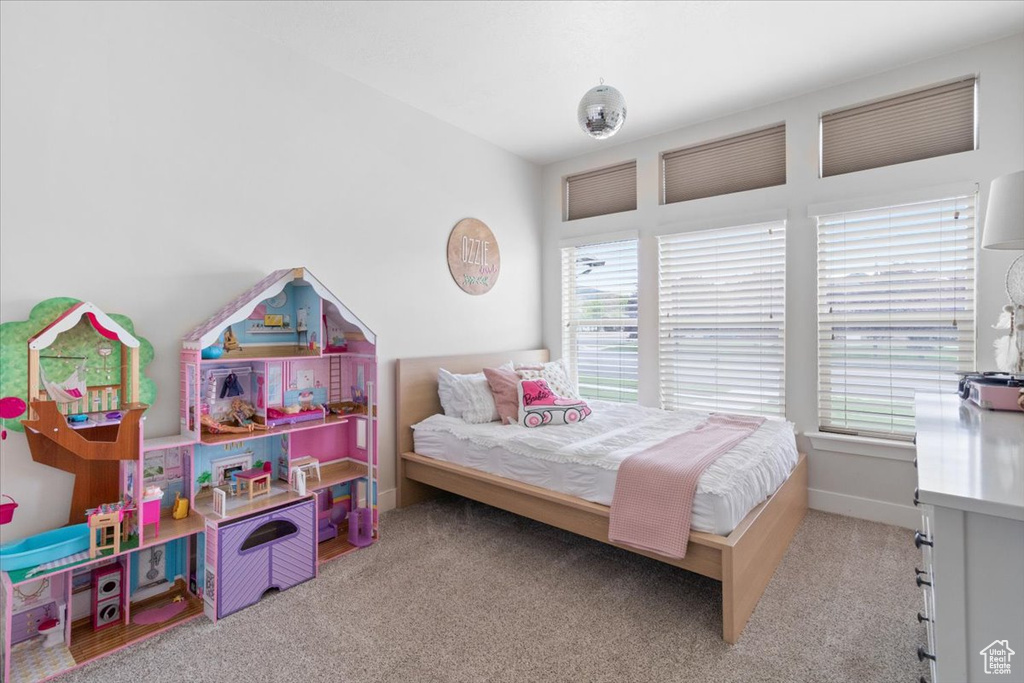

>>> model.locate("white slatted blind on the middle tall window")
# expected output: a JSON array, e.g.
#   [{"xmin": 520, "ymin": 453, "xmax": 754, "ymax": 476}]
[{"xmin": 658, "ymin": 221, "xmax": 785, "ymax": 416}]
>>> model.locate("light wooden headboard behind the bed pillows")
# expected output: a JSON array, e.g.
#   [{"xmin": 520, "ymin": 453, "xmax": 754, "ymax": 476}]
[{"xmin": 394, "ymin": 348, "xmax": 550, "ymax": 455}]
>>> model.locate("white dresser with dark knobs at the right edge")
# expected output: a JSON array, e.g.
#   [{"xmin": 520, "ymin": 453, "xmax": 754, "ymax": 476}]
[{"xmin": 907, "ymin": 394, "xmax": 1024, "ymax": 683}]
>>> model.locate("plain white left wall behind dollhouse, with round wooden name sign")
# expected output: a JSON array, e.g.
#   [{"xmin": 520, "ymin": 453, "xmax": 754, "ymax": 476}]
[{"xmin": 0, "ymin": 2, "xmax": 541, "ymax": 541}]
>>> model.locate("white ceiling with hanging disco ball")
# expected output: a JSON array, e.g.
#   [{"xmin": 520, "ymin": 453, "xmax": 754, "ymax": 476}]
[{"xmin": 216, "ymin": 0, "xmax": 1024, "ymax": 164}]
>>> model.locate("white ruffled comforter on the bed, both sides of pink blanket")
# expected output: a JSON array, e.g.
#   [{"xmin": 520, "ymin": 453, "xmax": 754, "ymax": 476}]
[{"xmin": 413, "ymin": 400, "xmax": 798, "ymax": 501}]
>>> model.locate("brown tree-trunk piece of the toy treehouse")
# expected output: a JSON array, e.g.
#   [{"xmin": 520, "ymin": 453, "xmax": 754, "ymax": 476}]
[{"xmin": 22, "ymin": 400, "xmax": 147, "ymax": 524}]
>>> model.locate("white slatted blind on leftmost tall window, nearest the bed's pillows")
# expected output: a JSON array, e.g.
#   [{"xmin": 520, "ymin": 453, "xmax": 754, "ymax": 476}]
[{"xmin": 562, "ymin": 240, "xmax": 638, "ymax": 402}]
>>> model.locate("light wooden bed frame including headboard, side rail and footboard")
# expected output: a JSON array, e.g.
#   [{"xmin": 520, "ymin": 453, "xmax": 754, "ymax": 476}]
[{"xmin": 395, "ymin": 349, "xmax": 807, "ymax": 643}]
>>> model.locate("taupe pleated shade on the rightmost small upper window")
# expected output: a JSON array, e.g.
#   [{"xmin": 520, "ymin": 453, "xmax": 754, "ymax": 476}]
[{"xmin": 821, "ymin": 78, "xmax": 977, "ymax": 177}]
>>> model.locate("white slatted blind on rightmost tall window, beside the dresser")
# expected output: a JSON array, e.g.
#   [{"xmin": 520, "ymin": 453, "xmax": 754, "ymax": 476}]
[{"xmin": 818, "ymin": 195, "xmax": 975, "ymax": 440}]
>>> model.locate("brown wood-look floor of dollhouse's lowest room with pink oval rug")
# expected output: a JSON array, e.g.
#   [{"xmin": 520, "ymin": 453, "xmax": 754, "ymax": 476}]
[{"xmin": 71, "ymin": 579, "xmax": 203, "ymax": 665}]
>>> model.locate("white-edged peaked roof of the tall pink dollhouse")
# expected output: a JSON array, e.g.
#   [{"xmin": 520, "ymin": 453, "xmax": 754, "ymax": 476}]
[{"xmin": 184, "ymin": 268, "xmax": 377, "ymax": 349}]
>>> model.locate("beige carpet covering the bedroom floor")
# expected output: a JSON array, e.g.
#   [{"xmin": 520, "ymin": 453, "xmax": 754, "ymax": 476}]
[{"xmin": 59, "ymin": 498, "xmax": 925, "ymax": 683}]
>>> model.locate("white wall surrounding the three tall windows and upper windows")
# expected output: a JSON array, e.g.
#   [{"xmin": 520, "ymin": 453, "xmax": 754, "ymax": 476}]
[{"xmin": 543, "ymin": 35, "xmax": 1024, "ymax": 526}]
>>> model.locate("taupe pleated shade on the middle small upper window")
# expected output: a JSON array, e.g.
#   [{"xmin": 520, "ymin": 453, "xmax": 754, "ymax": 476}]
[{"xmin": 662, "ymin": 124, "xmax": 785, "ymax": 204}]
